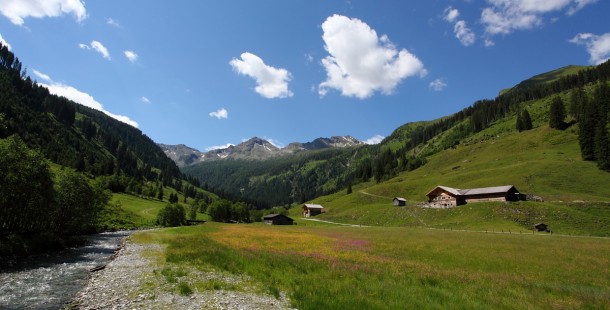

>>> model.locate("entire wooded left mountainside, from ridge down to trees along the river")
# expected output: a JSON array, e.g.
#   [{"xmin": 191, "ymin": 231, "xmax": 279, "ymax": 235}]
[{"xmin": 0, "ymin": 44, "xmax": 209, "ymax": 249}]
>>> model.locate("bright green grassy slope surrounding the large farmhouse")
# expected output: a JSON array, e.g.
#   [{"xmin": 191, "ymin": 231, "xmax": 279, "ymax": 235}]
[{"xmin": 291, "ymin": 95, "xmax": 610, "ymax": 236}]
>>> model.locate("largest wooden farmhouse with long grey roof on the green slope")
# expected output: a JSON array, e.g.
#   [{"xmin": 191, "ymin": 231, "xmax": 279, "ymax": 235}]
[{"xmin": 426, "ymin": 185, "xmax": 520, "ymax": 208}]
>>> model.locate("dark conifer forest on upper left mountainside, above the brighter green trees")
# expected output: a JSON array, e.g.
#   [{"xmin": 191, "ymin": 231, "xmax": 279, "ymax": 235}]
[{"xmin": 0, "ymin": 42, "xmax": 181, "ymax": 181}]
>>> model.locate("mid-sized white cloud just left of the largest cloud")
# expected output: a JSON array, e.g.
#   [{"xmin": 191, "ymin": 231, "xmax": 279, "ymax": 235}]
[{"xmin": 229, "ymin": 52, "xmax": 293, "ymax": 98}]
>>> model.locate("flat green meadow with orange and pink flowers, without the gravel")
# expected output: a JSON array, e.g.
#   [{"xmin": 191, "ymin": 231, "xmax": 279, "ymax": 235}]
[{"xmin": 133, "ymin": 223, "xmax": 610, "ymax": 309}]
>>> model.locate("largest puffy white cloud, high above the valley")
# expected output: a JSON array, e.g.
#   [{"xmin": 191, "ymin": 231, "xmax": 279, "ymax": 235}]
[{"xmin": 318, "ymin": 15, "xmax": 427, "ymax": 99}]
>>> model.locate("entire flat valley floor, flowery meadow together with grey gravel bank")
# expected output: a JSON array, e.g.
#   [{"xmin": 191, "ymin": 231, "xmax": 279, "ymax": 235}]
[{"xmin": 66, "ymin": 223, "xmax": 610, "ymax": 309}]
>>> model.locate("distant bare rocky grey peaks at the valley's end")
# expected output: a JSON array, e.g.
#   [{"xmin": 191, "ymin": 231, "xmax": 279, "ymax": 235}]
[{"xmin": 158, "ymin": 136, "xmax": 365, "ymax": 167}]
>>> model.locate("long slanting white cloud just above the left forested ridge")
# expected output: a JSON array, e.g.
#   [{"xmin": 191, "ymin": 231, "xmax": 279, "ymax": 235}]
[{"xmin": 32, "ymin": 70, "xmax": 138, "ymax": 128}]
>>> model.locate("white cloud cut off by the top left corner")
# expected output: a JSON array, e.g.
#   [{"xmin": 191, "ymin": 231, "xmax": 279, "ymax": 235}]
[{"xmin": 0, "ymin": 0, "xmax": 87, "ymax": 25}]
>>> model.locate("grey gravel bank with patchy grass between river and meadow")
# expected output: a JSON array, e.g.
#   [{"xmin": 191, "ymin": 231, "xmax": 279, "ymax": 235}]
[{"xmin": 66, "ymin": 236, "xmax": 290, "ymax": 310}]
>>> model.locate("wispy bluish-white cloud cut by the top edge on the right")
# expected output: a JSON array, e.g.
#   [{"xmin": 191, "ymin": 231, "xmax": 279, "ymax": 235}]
[{"xmin": 481, "ymin": 0, "xmax": 597, "ymax": 35}]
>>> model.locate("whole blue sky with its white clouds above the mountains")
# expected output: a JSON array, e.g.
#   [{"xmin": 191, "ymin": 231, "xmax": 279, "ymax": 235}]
[{"xmin": 0, "ymin": 0, "xmax": 610, "ymax": 150}]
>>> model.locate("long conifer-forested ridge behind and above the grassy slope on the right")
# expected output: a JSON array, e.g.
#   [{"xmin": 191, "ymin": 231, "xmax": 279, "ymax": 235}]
[{"xmin": 183, "ymin": 62, "xmax": 610, "ymax": 207}]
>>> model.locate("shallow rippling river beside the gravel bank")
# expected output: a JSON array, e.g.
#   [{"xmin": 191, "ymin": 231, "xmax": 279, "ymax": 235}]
[{"xmin": 0, "ymin": 232, "xmax": 130, "ymax": 309}]
